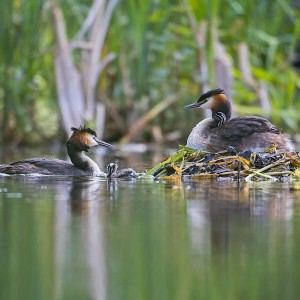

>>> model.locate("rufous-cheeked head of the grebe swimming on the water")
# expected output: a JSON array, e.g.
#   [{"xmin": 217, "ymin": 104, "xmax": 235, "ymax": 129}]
[{"xmin": 67, "ymin": 126, "xmax": 115, "ymax": 152}]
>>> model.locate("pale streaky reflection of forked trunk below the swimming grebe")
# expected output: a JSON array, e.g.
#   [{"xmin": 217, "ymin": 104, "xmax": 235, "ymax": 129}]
[{"xmin": 55, "ymin": 177, "xmax": 108, "ymax": 299}]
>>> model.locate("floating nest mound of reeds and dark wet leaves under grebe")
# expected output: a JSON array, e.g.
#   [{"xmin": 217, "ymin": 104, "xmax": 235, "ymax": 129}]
[{"xmin": 146, "ymin": 146, "xmax": 300, "ymax": 182}]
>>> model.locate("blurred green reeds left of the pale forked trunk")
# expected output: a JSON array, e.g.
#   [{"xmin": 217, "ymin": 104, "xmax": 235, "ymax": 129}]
[{"xmin": 0, "ymin": 0, "xmax": 57, "ymax": 143}]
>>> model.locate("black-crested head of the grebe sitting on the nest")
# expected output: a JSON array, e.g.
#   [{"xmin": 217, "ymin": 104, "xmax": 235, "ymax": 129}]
[{"xmin": 183, "ymin": 89, "xmax": 231, "ymax": 126}]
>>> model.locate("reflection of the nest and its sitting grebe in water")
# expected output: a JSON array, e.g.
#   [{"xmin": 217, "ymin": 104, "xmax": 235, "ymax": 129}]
[{"xmin": 184, "ymin": 180, "xmax": 295, "ymax": 253}]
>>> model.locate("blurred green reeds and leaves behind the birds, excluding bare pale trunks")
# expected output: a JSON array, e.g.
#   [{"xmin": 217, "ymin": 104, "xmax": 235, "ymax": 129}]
[{"xmin": 0, "ymin": 0, "xmax": 300, "ymax": 142}]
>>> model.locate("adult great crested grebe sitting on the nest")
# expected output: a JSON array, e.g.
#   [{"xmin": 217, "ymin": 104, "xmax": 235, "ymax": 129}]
[{"xmin": 183, "ymin": 89, "xmax": 294, "ymax": 152}]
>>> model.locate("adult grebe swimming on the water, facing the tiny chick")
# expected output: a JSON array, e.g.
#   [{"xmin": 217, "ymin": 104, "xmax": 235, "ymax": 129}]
[{"xmin": 0, "ymin": 126, "xmax": 115, "ymax": 176}]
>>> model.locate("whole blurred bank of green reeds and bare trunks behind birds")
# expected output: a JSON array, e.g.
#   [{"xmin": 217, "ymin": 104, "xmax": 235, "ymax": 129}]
[{"xmin": 0, "ymin": 0, "xmax": 300, "ymax": 145}]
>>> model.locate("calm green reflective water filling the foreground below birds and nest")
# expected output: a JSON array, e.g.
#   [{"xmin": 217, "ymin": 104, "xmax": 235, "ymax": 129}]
[{"xmin": 0, "ymin": 151, "xmax": 300, "ymax": 300}]
